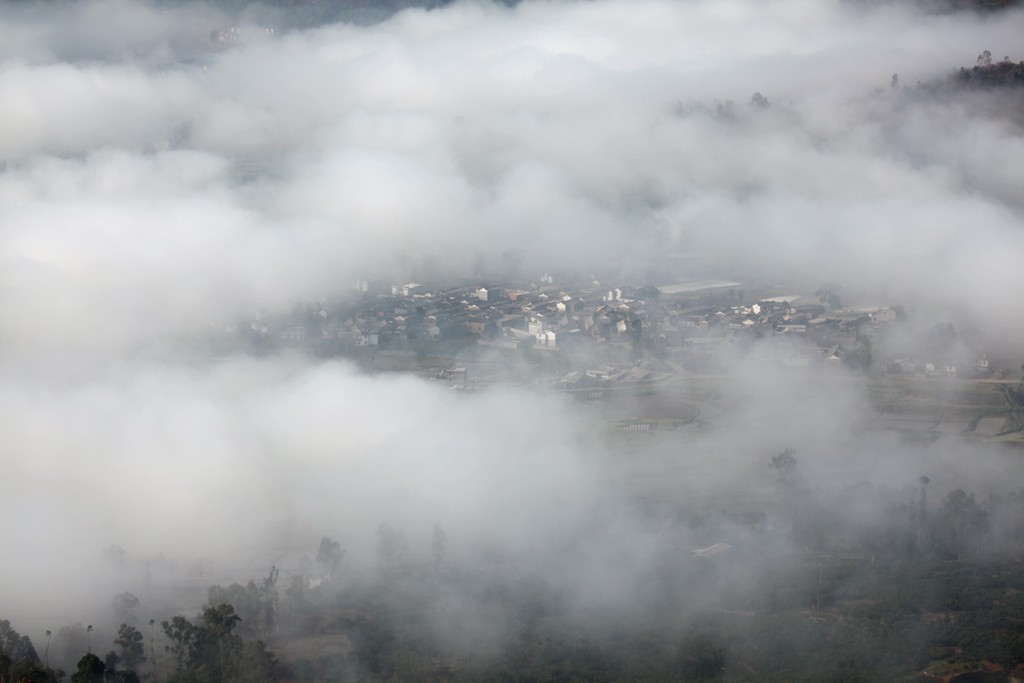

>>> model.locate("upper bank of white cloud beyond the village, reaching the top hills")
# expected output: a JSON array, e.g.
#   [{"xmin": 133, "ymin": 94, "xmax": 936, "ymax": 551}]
[{"xmin": 0, "ymin": 2, "xmax": 1024, "ymax": 345}]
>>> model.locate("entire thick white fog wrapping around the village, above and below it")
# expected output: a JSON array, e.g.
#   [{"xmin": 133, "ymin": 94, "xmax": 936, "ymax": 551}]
[{"xmin": 0, "ymin": 0, "xmax": 1024, "ymax": 643}]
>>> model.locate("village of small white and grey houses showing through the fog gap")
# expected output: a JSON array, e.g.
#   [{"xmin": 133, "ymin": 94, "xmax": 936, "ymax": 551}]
[{"xmin": 239, "ymin": 275, "xmax": 921, "ymax": 378}]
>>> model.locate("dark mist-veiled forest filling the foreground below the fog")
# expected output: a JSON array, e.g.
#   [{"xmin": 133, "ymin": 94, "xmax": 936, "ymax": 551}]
[{"xmin": 9, "ymin": 450, "xmax": 1024, "ymax": 683}]
